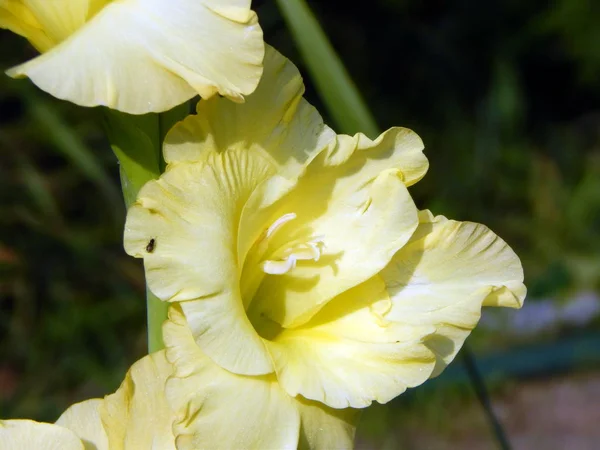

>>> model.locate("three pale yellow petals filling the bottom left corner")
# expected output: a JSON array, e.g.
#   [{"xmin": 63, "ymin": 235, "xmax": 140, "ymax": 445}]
[{"xmin": 0, "ymin": 351, "xmax": 175, "ymax": 450}]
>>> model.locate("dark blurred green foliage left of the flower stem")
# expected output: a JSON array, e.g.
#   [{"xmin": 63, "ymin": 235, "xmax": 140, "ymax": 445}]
[{"xmin": 0, "ymin": 68, "xmax": 145, "ymax": 419}]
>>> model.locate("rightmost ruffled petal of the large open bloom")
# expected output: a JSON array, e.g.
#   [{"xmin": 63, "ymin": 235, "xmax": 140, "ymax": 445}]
[{"xmin": 381, "ymin": 211, "xmax": 526, "ymax": 376}]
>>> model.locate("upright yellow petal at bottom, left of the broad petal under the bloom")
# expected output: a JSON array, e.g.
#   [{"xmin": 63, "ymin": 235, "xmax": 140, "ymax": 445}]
[{"xmin": 99, "ymin": 351, "xmax": 175, "ymax": 450}]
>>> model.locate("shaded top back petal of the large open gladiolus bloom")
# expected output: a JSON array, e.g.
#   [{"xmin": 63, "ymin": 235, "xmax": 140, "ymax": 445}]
[{"xmin": 164, "ymin": 46, "xmax": 335, "ymax": 178}]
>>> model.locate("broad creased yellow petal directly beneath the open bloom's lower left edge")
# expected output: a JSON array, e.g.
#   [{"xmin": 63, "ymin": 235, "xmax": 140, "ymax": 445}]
[{"xmin": 163, "ymin": 306, "xmax": 300, "ymax": 450}]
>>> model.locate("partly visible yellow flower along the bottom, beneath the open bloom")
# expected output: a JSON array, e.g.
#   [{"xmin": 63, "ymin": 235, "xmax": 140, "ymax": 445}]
[{"xmin": 0, "ymin": 340, "xmax": 356, "ymax": 450}]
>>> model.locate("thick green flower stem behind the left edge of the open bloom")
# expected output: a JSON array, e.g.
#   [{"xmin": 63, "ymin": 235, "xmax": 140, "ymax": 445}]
[{"xmin": 105, "ymin": 103, "xmax": 188, "ymax": 353}]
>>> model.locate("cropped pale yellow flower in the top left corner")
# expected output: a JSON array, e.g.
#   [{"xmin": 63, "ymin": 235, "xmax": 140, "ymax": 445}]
[{"xmin": 0, "ymin": 0, "xmax": 264, "ymax": 114}]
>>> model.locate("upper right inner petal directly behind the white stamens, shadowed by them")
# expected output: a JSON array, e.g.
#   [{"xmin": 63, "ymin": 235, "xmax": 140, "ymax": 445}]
[{"xmin": 251, "ymin": 129, "xmax": 427, "ymax": 328}]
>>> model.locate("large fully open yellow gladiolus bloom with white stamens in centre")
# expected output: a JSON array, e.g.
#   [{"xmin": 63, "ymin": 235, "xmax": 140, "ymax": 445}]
[{"xmin": 125, "ymin": 45, "xmax": 525, "ymax": 408}]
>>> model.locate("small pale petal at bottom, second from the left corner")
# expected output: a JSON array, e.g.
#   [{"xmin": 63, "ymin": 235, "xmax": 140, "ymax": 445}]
[{"xmin": 56, "ymin": 398, "xmax": 108, "ymax": 450}]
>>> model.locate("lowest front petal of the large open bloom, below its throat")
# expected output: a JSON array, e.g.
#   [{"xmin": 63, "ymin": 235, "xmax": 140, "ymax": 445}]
[{"xmin": 267, "ymin": 277, "xmax": 435, "ymax": 408}]
